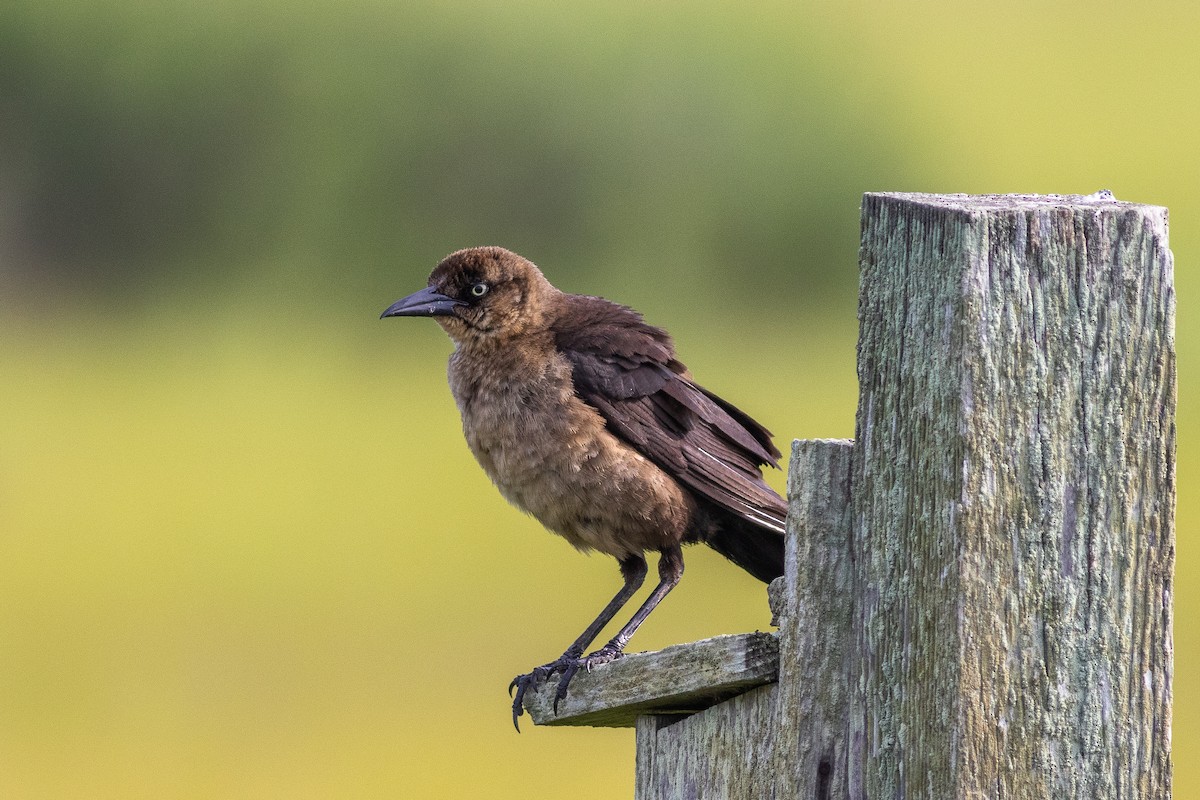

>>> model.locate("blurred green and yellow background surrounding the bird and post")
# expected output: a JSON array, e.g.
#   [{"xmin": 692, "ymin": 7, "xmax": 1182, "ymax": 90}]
[{"xmin": 0, "ymin": 0, "xmax": 1200, "ymax": 798}]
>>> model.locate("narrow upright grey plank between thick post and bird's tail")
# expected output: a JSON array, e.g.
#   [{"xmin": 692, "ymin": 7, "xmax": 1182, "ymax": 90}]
[{"xmin": 770, "ymin": 439, "xmax": 862, "ymax": 800}]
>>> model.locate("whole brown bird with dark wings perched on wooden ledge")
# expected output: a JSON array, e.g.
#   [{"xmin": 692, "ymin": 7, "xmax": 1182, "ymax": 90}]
[{"xmin": 382, "ymin": 247, "xmax": 787, "ymax": 730}]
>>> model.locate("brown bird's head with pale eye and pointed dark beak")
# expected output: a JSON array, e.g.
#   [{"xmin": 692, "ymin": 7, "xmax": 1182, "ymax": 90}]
[{"xmin": 380, "ymin": 247, "xmax": 557, "ymax": 344}]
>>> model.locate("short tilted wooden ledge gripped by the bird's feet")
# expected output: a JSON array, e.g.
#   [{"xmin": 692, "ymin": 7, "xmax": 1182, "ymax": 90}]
[{"xmin": 526, "ymin": 632, "xmax": 779, "ymax": 728}]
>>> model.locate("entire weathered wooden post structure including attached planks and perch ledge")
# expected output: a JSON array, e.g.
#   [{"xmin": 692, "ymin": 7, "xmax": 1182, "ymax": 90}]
[{"xmin": 518, "ymin": 193, "xmax": 1175, "ymax": 800}]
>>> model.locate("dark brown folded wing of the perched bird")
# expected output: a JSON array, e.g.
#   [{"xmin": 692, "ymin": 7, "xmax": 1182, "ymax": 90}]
[{"xmin": 554, "ymin": 297, "xmax": 787, "ymax": 533}]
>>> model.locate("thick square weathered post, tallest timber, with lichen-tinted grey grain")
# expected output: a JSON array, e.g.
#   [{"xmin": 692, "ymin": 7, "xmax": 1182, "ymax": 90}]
[{"xmin": 851, "ymin": 194, "xmax": 1176, "ymax": 799}]
